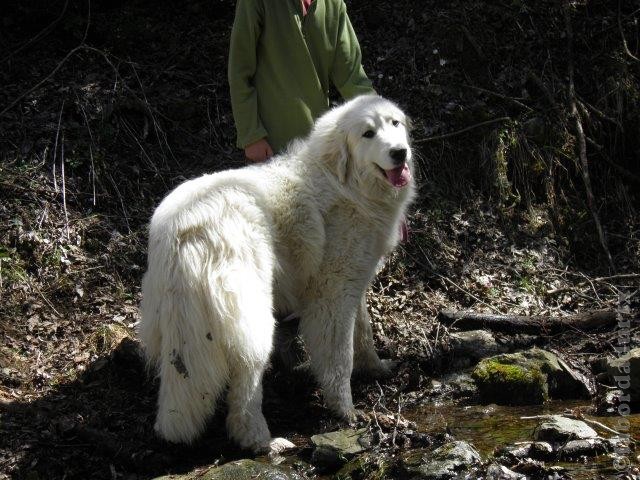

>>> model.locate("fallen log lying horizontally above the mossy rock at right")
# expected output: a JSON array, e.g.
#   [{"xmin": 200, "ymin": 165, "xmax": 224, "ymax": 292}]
[{"xmin": 438, "ymin": 310, "xmax": 628, "ymax": 334}]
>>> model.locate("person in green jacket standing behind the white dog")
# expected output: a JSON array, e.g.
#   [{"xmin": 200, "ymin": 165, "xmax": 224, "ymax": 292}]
[{"xmin": 228, "ymin": 0, "xmax": 375, "ymax": 162}]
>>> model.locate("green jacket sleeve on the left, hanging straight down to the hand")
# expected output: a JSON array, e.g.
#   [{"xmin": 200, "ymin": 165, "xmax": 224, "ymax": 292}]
[{"xmin": 227, "ymin": 0, "xmax": 267, "ymax": 148}]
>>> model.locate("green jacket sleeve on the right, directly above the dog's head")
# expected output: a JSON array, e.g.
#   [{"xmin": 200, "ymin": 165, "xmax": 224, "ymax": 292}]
[{"xmin": 331, "ymin": 1, "xmax": 375, "ymax": 100}]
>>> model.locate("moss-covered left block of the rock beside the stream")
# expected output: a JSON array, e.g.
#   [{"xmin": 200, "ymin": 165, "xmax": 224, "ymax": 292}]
[{"xmin": 472, "ymin": 359, "xmax": 549, "ymax": 405}]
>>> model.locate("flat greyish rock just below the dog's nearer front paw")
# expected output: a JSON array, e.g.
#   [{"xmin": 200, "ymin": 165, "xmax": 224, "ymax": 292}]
[{"xmin": 311, "ymin": 428, "xmax": 371, "ymax": 471}]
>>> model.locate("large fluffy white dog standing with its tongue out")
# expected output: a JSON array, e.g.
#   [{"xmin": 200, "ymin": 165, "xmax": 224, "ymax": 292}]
[{"xmin": 139, "ymin": 96, "xmax": 414, "ymax": 451}]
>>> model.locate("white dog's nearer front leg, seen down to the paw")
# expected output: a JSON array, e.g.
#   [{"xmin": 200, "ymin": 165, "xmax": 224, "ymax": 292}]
[{"xmin": 300, "ymin": 292, "xmax": 359, "ymax": 421}]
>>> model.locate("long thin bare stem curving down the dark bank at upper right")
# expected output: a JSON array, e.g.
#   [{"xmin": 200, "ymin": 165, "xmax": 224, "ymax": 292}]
[{"xmin": 563, "ymin": 1, "xmax": 615, "ymax": 272}]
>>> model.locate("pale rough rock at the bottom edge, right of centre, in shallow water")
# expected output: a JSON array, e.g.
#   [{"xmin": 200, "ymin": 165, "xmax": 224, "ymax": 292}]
[{"xmin": 402, "ymin": 441, "xmax": 481, "ymax": 480}]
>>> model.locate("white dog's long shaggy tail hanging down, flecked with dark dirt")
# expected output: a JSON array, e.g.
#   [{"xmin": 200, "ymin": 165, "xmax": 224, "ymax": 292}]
[{"xmin": 138, "ymin": 224, "xmax": 236, "ymax": 443}]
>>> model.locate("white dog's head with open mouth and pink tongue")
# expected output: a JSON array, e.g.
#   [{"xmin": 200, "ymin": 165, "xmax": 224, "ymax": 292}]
[{"xmin": 314, "ymin": 95, "xmax": 413, "ymax": 190}]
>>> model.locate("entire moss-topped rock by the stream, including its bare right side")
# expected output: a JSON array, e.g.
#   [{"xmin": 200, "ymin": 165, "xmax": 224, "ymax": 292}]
[{"xmin": 472, "ymin": 348, "xmax": 591, "ymax": 405}]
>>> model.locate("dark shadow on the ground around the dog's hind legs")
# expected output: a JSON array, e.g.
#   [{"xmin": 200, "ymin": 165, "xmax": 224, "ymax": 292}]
[{"xmin": 0, "ymin": 338, "xmax": 327, "ymax": 480}]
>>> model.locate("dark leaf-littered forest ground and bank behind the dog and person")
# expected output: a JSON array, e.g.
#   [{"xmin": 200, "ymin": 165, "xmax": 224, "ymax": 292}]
[{"xmin": 0, "ymin": 0, "xmax": 640, "ymax": 479}]
